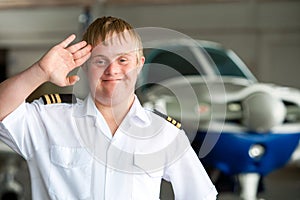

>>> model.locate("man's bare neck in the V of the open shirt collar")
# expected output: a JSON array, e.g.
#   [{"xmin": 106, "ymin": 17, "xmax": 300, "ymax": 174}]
[{"xmin": 95, "ymin": 95, "xmax": 134, "ymax": 135}]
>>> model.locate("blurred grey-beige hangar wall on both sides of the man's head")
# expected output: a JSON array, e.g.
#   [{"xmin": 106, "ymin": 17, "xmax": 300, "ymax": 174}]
[{"xmin": 0, "ymin": 0, "xmax": 300, "ymax": 92}]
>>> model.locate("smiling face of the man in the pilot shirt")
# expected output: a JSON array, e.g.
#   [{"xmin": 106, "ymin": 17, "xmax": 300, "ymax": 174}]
[{"xmin": 87, "ymin": 33, "xmax": 145, "ymax": 106}]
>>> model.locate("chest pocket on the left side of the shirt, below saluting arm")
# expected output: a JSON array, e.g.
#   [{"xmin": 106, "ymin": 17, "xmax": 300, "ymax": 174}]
[{"xmin": 49, "ymin": 146, "xmax": 92, "ymax": 200}]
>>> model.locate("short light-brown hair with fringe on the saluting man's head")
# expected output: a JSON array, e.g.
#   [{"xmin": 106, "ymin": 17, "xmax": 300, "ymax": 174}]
[{"xmin": 83, "ymin": 16, "xmax": 143, "ymax": 59}]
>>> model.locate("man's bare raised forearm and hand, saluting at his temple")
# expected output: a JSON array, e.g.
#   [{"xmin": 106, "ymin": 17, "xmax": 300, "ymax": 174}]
[{"xmin": 0, "ymin": 35, "xmax": 91, "ymax": 121}]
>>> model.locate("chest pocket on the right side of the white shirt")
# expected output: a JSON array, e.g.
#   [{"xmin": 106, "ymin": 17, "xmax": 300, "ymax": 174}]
[{"xmin": 132, "ymin": 154, "xmax": 164, "ymax": 200}]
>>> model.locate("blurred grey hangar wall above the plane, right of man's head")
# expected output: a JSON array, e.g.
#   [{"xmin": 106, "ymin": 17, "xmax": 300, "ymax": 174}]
[{"xmin": 98, "ymin": 1, "xmax": 300, "ymax": 88}]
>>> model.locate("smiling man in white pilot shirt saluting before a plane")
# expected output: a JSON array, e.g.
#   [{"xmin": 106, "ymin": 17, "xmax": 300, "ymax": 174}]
[{"xmin": 0, "ymin": 17, "xmax": 217, "ymax": 200}]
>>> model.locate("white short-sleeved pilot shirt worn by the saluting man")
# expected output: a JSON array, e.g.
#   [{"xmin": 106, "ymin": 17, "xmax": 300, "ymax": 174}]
[{"xmin": 0, "ymin": 95, "xmax": 217, "ymax": 200}]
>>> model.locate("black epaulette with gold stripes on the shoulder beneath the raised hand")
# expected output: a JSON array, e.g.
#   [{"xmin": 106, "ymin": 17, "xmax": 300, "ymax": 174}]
[{"xmin": 42, "ymin": 94, "xmax": 77, "ymax": 105}]
